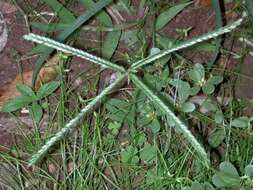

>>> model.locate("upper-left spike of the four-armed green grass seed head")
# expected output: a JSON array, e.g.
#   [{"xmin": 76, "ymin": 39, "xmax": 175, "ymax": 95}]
[{"xmin": 24, "ymin": 33, "xmax": 125, "ymax": 72}]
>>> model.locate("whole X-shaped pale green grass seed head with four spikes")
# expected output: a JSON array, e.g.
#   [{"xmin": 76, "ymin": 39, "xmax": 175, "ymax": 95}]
[{"xmin": 24, "ymin": 18, "xmax": 243, "ymax": 167}]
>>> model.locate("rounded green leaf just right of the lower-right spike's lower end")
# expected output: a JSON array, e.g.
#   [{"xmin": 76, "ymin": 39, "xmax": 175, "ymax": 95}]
[{"xmin": 207, "ymin": 127, "xmax": 226, "ymax": 148}]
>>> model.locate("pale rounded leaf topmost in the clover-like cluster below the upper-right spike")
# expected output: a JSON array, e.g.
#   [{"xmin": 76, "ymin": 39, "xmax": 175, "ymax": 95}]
[{"xmin": 188, "ymin": 63, "xmax": 205, "ymax": 84}]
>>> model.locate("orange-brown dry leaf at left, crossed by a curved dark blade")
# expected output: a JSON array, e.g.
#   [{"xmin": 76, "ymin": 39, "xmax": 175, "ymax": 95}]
[{"xmin": 0, "ymin": 55, "xmax": 59, "ymax": 107}]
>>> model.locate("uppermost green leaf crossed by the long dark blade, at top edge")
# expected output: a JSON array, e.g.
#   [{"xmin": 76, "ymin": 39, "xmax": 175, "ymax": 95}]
[{"xmin": 80, "ymin": 0, "xmax": 112, "ymax": 26}]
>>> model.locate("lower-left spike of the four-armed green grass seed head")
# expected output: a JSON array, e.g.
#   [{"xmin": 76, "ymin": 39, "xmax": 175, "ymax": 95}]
[{"xmin": 28, "ymin": 74, "xmax": 126, "ymax": 166}]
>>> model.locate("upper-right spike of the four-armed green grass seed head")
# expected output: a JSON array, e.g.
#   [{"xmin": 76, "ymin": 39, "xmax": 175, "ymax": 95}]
[{"xmin": 130, "ymin": 18, "xmax": 243, "ymax": 70}]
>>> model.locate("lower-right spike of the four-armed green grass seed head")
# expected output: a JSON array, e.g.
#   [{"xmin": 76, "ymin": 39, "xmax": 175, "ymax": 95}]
[{"xmin": 130, "ymin": 74, "xmax": 210, "ymax": 166}]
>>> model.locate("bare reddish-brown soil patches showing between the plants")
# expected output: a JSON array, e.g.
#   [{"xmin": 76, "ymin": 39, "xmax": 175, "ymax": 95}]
[{"xmin": 0, "ymin": 0, "xmax": 253, "ymax": 160}]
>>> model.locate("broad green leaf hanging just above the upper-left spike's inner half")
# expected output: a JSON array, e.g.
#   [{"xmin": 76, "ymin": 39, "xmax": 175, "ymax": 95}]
[{"xmin": 102, "ymin": 31, "xmax": 121, "ymax": 60}]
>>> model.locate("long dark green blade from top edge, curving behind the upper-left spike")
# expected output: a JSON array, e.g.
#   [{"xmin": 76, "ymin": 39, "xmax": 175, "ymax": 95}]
[{"xmin": 32, "ymin": 0, "xmax": 112, "ymax": 86}]
